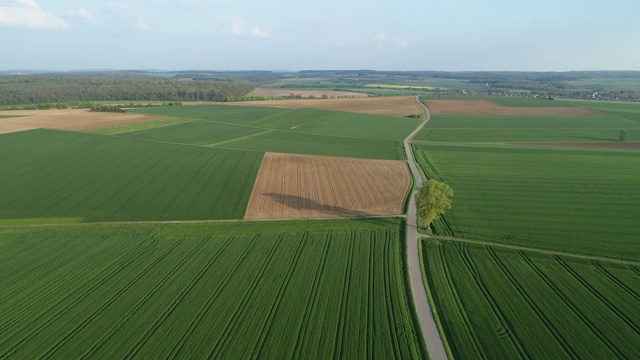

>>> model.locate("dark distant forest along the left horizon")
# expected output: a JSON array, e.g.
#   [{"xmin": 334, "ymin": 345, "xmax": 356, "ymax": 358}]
[{"xmin": 0, "ymin": 72, "xmax": 253, "ymax": 105}]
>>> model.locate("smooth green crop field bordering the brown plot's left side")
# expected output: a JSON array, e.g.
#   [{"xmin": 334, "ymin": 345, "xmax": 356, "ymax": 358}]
[{"xmin": 0, "ymin": 129, "xmax": 263, "ymax": 221}]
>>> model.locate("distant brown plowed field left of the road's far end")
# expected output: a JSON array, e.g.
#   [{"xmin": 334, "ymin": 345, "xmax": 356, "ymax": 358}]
[{"xmin": 228, "ymin": 96, "xmax": 423, "ymax": 116}]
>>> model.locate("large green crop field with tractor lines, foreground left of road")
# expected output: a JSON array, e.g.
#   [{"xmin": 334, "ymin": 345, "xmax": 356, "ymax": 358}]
[{"xmin": 0, "ymin": 219, "xmax": 427, "ymax": 359}]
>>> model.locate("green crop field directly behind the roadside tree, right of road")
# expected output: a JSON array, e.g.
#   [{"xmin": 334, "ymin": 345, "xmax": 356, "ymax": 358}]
[{"xmin": 415, "ymin": 144, "xmax": 640, "ymax": 259}]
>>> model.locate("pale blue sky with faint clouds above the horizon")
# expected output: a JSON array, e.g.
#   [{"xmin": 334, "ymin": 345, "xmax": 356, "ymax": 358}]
[{"xmin": 0, "ymin": 0, "xmax": 640, "ymax": 71}]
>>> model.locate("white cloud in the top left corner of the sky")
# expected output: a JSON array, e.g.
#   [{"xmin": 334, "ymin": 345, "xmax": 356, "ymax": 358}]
[{"xmin": 0, "ymin": 0, "xmax": 69, "ymax": 29}]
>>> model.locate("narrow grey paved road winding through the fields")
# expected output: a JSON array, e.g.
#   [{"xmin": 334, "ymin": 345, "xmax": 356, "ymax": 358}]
[{"xmin": 404, "ymin": 96, "xmax": 447, "ymax": 360}]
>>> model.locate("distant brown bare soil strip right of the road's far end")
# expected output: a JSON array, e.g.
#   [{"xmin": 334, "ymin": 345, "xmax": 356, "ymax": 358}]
[{"xmin": 427, "ymin": 100, "xmax": 597, "ymax": 115}]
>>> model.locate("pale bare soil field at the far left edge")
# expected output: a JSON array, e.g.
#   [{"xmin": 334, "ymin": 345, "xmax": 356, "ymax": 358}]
[{"xmin": 0, "ymin": 109, "xmax": 157, "ymax": 134}]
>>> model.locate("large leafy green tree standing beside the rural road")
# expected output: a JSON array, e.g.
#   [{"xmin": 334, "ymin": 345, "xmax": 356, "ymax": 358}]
[{"xmin": 416, "ymin": 180, "xmax": 453, "ymax": 228}]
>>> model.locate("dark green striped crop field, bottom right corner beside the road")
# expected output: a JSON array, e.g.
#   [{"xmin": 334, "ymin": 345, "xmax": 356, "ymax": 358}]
[{"xmin": 422, "ymin": 239, "xmax": 640, "ymax": 359}]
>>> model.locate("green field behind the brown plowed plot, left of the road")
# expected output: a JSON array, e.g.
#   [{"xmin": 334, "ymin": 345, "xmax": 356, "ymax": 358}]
[{"xmin": 125, "ymin": 105, "xmax": 410, "ymax": 160}]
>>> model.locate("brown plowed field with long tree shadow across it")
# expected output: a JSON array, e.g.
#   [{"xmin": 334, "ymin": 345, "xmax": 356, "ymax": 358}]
[{"xmin": 245, "ymin": 153, "xmax": 411, "ymax": 219}]
